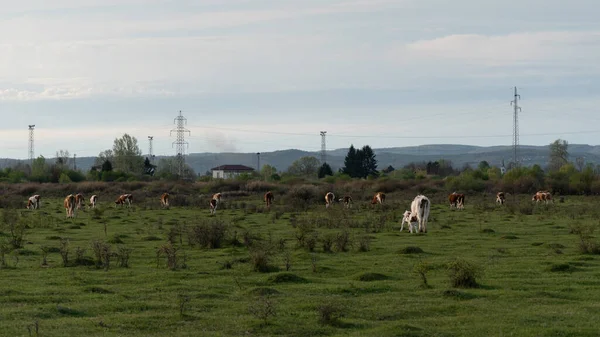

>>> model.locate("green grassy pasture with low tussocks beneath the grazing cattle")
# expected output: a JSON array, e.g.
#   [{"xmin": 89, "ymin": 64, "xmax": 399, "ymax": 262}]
[{"xmin": 0, "ymin": 190, "xmax": 600, "ymax": 336}]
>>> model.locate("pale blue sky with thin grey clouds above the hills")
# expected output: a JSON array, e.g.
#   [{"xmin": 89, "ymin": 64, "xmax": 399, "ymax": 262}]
[{"xmin": 0, "ymin": 0, "xmax": 600, "ymax": 158}]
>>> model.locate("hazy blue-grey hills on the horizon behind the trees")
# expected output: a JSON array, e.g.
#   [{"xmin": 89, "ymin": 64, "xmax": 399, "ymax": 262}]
[{"xmin": 0, "ymin": 144, "xmax": 600, "ymax": 174}]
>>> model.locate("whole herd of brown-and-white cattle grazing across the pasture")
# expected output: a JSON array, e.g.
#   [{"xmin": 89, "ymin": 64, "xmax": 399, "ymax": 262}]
[{"xmin": 27, "ymin": 191, "xmax": 554, "ymax": 233}]
